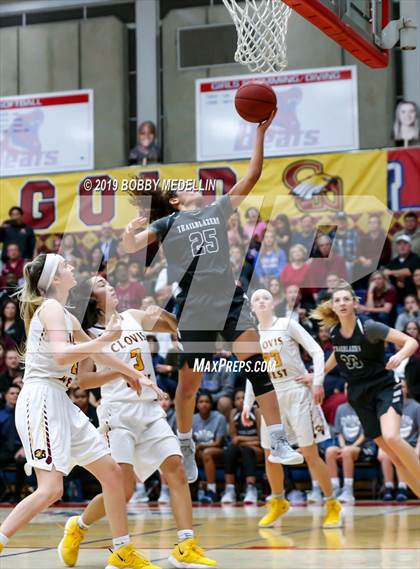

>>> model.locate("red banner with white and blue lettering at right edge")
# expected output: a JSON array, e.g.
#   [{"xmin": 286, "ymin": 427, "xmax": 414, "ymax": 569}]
[{"xmin": 388, "ymin": 147, "xmax": 420, "ymax": 211}]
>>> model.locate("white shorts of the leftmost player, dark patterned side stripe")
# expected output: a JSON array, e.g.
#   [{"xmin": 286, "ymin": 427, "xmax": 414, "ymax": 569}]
[{"xmin": 15, "ymin": 380, "xmax": 109, "ymax": 475}]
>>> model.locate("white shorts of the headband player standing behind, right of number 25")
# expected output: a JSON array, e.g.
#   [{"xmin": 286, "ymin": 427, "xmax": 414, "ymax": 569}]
[{"xmin": 261, "ymin": 386, "xmax": 330, "ymax": 449}]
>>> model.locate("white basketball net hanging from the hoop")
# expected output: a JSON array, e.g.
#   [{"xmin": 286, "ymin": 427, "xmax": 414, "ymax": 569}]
[{"xmin": 223, "ymin": 0, "xmax": 292, "ymax": 72}]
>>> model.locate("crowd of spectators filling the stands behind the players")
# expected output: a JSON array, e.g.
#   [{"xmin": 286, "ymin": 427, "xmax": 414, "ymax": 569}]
[{"xmin": 0, "ymin": 203, "xmax": 420, "ymax": 503}]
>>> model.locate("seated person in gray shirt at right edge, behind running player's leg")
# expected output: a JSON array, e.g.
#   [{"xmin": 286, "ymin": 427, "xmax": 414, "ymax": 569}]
[{"xmin": 378, "ymin": 380, "xmax": 420, "ymax": 502}]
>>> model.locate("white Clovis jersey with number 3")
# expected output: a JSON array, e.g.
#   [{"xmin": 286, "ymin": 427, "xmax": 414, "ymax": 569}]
[{"xmin": 88, "ymin": 310, "xmax": 156, "ymax": 403}]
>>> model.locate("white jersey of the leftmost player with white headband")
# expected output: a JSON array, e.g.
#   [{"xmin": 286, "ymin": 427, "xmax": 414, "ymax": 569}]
[{"xmin": 23, "ymin": 298, "xmax": 77, "ymax": 390}]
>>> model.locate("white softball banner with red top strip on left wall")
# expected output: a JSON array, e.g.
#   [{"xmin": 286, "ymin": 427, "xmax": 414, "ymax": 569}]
[{"xmin": 0, "ymin": 90, "xmax": 94, "ymax": 177}]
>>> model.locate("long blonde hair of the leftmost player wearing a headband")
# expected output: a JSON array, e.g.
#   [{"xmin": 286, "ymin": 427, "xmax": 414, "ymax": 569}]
[{"xmin": 16, "ymin": 254, "xmax": 47, "ymax": 333}]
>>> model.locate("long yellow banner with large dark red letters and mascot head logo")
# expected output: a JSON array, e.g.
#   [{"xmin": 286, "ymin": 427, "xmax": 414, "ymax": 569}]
[{"xmin": 0, "ymin": 150, "xmax": 387, "ymax": 234}]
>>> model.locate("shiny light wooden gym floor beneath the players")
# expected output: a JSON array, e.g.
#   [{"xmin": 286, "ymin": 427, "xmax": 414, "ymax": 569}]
[{"xmin": 0, "ymin": 502, "xmax": 420, "ymax": 569}]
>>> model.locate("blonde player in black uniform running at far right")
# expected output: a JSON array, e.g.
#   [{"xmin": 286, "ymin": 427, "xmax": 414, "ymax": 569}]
[{"xmin": 312, "ymin": 281, "xmax": 420, "ymax": 497}]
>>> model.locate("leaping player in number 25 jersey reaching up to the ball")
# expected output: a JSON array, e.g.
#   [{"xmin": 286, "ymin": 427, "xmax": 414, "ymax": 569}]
[{"xmin": 123, "ymin": 108, "xmax": 303, "ymax": 482}]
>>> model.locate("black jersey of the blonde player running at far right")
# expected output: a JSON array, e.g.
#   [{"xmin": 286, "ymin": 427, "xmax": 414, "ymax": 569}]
[{"xmin": 330, "ymin": 319, "xmax": 393, "ymax": 383}]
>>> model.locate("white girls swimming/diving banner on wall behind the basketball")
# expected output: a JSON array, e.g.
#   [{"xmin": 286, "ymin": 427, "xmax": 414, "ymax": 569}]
[{"xmin": 196, "ymin": 66, "xmax": 359, "ymax": 161}]
